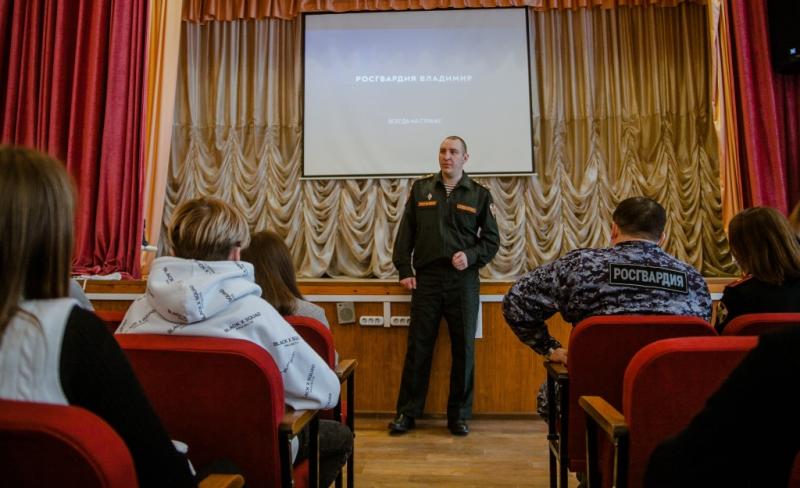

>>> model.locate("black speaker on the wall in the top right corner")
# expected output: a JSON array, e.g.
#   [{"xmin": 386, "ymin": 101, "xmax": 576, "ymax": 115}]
[{"xmin": 767, "ymin": 0, "xmax": 800, "ymax": 73}]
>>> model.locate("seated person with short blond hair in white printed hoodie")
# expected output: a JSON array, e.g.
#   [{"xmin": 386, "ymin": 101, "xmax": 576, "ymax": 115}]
[{"xmin": 117, "ymin": 198, "xmax": 353, "ymax": 486}]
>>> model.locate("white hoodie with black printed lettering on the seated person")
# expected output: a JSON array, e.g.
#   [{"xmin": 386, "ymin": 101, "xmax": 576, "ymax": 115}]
[{"xmin": 117, "ymin": 257, "xmax": 339, "ymax": 410}]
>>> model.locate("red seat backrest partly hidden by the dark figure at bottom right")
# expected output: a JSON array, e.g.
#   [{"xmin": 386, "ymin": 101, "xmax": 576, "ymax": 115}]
[{"xmin": 620, "ymin": 337, "xmax": 758, "ymax": 488}]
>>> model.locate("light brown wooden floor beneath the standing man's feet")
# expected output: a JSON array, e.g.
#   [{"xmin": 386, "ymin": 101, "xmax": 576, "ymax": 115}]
[{"xmin": 355, "ymin": 415, "xmax": 578, "ymax": 488}]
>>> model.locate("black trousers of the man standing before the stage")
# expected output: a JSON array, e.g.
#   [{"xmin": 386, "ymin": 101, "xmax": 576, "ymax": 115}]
[{"xmin": 397, "ymin": 261, "xmax": 480, "ymax": 420}]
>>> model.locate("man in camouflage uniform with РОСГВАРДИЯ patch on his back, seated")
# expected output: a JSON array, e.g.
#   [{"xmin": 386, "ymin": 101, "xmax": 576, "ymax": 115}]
[{"xmin": 503, "ymin": 197, "xmax": 711, "ymax": 364}]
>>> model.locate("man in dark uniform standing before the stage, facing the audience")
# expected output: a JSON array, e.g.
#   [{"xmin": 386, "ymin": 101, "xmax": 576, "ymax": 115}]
[{"xmin": 389, "ymin": 136, "xmax": 499, "ymax": 435}]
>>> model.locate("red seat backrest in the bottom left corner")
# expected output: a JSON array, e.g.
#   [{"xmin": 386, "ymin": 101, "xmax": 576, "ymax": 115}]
[{"xmin": 0, "ymin": 400, "xmax": 138, "ymax": 488}]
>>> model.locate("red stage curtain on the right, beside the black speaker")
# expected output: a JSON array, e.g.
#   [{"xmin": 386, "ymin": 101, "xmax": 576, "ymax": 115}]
[{"xmin": 730, "ymin": 0, "xmax": 800, "ymax": 213}]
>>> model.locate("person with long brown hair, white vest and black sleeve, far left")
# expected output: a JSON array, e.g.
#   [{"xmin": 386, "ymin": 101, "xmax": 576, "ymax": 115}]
[{"xmin": 0, "ymin": 147, "xmax": 196, "ymax": 486}]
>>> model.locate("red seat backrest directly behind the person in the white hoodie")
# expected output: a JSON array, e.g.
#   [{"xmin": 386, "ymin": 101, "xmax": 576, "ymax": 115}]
[{"xmin": 116, "ymin": 334, "xmax": 285, "ymax": 488}]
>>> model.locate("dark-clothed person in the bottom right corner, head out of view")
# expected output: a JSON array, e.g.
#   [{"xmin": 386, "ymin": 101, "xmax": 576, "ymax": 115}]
[{"xmin": 644, "ymin": 329, "xmax": 800, "ymax": 488}]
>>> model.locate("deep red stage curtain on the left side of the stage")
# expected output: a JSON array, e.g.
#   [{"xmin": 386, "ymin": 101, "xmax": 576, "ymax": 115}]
[{"xmin": 0, "ymin": 0, "xmax": 147, "ymax": 277}]
